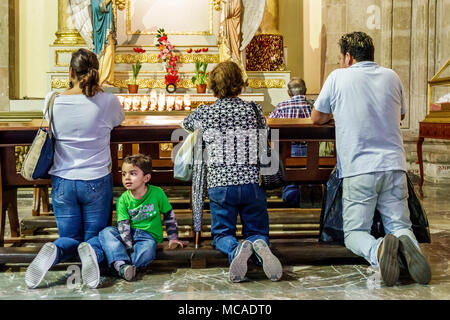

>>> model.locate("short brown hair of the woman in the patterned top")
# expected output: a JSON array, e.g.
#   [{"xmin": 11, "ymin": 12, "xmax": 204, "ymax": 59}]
[{"xmin": 208, "ymin": 61, "xmax": 245, "ymax": 99}]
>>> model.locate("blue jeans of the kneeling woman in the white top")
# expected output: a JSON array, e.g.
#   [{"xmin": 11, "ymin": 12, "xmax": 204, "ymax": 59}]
[{"xmin": 52, "ymin": 174, "xmax": 113, "ymax": 264}]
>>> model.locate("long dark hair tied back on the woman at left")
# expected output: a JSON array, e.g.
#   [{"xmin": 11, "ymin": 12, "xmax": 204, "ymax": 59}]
[{"xmin": 69, "ymin": 49, "xmax": 103, "ymax": 97}]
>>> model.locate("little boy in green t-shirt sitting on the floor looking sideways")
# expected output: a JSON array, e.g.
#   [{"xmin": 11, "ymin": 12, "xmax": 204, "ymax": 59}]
[{"xmin": 99, "ymin": 154, "xmax": 184, "ymax": 281}]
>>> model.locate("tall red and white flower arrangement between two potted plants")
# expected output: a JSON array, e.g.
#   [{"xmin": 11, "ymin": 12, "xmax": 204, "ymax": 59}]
[{"xmin": 156, "ymin": 29, "xmax": 179, "ymax": 85}]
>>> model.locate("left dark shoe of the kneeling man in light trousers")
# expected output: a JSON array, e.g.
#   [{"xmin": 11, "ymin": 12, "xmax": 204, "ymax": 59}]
[{"xmin": 380, "ymin": 234, "xmax": 400, "ymax": 287}]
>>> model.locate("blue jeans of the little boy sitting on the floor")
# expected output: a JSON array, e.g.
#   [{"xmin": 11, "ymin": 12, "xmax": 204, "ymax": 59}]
[{"xmin": 99, "ymin": 227, "xmax": 157, "ymax": 269}]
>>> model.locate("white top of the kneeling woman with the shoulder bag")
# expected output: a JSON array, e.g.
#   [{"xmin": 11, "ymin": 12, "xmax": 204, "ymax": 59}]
[{"xmin": 44, "ymin": 92, "xmax": 125, "ymax": 180}]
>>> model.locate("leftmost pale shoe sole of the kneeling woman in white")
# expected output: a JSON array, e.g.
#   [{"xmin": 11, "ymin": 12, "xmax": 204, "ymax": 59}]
[{"xmin": 25, "ymin": 242, "xmax": 58, "ymax": 289}]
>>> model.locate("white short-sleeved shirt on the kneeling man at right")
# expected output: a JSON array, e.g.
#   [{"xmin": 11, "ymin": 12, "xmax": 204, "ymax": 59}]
[{"xmin": 314, "ymin": 61, "xmax": 406, "ymax": 178}]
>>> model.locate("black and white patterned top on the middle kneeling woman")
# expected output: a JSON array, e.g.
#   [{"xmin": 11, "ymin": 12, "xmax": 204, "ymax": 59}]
[{"xmin": 183, "ymin": 98, "xmax": 266, "ymax": 188}]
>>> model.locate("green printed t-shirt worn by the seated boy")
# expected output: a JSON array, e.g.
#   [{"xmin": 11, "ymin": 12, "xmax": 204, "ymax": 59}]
[{"xmin": 117, "ymin": 184, "xmax": 172, "ymax": 242}]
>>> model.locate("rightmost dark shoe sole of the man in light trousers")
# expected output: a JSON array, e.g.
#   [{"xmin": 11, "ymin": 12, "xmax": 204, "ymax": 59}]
[{"xmin": 398, "ymin": 235, "xmax": 431, "ymax": 284}]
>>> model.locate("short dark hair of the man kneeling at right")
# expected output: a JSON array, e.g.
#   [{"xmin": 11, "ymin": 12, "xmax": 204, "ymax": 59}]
[{"xmin": 339, "ymin": 32, "xmax": 375, "ymax": 62}]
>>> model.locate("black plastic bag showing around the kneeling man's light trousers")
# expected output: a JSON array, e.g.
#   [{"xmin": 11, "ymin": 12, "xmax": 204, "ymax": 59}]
[{"xmin": 319, "ymin": 169, "xmax": 431, "ymax": 245}]
